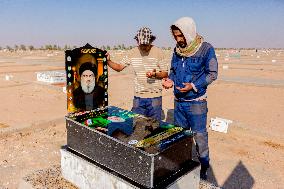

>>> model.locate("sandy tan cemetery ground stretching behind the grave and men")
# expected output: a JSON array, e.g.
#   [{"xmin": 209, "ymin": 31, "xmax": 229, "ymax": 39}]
[{"xmin": 0, "ymin": 50, "xmax": 284, "ymax": 189}]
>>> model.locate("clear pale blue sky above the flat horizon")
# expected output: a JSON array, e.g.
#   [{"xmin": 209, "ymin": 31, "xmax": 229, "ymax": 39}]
[{"xmin": 0, "ymin": 0, "xmax": 284, "ymax": 48}]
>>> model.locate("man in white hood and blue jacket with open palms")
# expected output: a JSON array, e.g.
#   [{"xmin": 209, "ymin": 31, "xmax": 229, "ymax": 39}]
[{"xmin": 163, "ymin": 17, "xmax": 218, "ymax": 180}]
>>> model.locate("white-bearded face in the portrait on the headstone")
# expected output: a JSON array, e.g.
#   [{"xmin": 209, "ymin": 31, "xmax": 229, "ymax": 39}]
[{"xmin": 81, "ymin": 70, "xmax": 96, "ymax": 93}]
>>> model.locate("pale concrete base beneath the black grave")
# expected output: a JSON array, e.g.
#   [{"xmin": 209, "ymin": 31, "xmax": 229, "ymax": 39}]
[{"xmin": 61, "ymin": 148, "xmax": 200, "ymax": 189}]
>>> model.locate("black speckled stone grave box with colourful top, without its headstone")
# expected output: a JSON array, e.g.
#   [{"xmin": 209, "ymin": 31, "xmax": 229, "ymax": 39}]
[{"xmin": 66, "ymin": 107, "xmax": 193, "ymax": 188}]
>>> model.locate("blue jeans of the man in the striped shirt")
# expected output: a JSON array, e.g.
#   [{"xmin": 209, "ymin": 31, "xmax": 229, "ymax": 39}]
[{"xmin": 131, "ymin": 96, "xmax": 162, "ymax": 121}]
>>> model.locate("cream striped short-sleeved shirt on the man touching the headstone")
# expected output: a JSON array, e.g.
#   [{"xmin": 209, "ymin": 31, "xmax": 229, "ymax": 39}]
[{"xmin": 120, "ymin": 46, "xmax": 168, "ymax": 98}]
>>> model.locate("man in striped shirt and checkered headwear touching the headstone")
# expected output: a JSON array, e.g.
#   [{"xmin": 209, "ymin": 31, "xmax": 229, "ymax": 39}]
[{"xmin": 107, "ymin": 27, "xmax": 168, "ymax": 120}]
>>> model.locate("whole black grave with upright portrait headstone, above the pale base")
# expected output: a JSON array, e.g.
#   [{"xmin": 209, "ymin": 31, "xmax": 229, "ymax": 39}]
[{"xmin": 62, "ymin": 44, "xmax": 199, "ymax": 188}]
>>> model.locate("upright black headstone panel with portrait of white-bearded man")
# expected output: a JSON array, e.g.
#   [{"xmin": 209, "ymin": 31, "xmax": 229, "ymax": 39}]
[{"xmin": 65, "ymin": 44, "xmax": 108, "ymax": 114}]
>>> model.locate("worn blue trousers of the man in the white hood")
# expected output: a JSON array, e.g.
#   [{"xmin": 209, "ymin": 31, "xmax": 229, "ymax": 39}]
[{"xmin": 174, "ymin": 100, "xmax": 209, "ymax": 168}]
